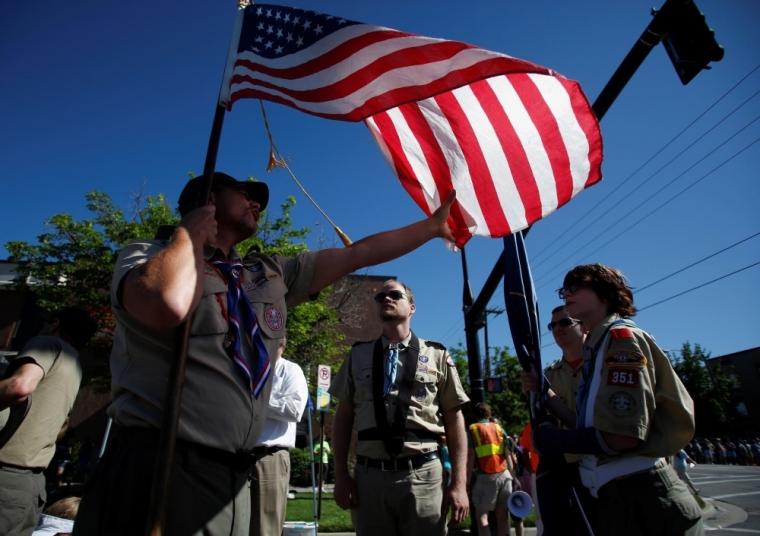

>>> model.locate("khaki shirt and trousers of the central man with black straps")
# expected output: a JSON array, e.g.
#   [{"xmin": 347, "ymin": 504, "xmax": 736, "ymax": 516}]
[{"xmin": 329, "ymin": 333, "xmax": 469, "ymax": 536}]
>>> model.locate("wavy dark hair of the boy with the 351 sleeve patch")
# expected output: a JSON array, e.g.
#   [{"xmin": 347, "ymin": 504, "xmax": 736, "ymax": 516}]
[{"xmin": 563, "ymin": 263, "xmax": 636, "ymax": 318}]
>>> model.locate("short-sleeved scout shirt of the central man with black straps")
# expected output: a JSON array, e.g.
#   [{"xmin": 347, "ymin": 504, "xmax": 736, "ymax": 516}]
[{"xmin": 328, "ymin": 332, "xmax": 469, "ymax": 460}]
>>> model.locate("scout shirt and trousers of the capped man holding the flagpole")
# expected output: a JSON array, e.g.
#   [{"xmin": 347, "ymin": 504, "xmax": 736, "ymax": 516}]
[{"xmin": 75, "ymin": 240, "xmax": 317, "ymax": 535}]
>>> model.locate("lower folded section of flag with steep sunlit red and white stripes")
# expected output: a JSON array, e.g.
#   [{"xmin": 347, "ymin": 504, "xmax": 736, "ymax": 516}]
[{"xmin": 365, "ymin": 73, "xmax": 602, "ymax": 247}]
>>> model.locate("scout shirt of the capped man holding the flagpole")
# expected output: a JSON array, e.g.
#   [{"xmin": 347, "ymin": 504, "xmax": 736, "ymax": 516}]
[{"xmin": 108, "ymin": 240, "xmax": 317, "ymax": 452}]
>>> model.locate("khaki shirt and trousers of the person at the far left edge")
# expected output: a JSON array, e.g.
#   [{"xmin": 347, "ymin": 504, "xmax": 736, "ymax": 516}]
[{"xmin": 0, "ymin": 336, "xmax": 82, "ymax": 535}]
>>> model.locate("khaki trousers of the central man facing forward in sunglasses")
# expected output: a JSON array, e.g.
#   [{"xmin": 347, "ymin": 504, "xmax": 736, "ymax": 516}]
[{"xmin": 351, "ymin": 460, "xmax": 446, "ymax": 536}]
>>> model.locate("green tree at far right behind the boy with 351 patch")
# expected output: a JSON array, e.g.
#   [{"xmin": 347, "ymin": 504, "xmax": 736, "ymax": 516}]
[{"xmin": 670, "ymin": 342, "xmax": 736, "ymax": 436}]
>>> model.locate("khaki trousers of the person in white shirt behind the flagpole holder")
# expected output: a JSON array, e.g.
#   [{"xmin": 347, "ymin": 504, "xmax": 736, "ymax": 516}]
[{"xmin": 250, "ymin": 450, "xmax": 290, "ymax": 536}]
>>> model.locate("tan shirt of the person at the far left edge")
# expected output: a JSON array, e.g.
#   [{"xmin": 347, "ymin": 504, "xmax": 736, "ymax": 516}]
[{"xmin": 0, "ymin": 336, "xmax": 82, "ymax": 468}]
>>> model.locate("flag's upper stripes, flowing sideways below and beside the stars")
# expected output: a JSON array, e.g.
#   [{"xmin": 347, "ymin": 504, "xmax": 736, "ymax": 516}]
[{"xmin": 220, "ymin": 21, "xmax": 551, "ymax": 121}]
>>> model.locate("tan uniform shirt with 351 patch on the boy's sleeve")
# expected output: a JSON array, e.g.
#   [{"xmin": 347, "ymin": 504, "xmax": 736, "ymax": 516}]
[{"xmin": 586, "ymin": 314, "xmax": 694, "ymax": 463}]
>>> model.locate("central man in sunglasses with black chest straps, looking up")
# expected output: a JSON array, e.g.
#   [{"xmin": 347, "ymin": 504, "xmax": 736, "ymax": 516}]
[{"xmin": 329, "ymin": 280, "xmax": 469, "ymax": 536}]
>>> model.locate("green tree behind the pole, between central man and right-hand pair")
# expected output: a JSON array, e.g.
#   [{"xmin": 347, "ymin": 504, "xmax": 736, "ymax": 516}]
[{"xmin": 449, "ymin": 343, "xmax": 529, "ymax": 434}]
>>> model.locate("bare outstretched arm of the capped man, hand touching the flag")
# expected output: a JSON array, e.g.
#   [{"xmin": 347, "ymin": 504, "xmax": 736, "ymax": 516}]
[{"xmin": 309, "ymin": 190, "xmax": 456, "ymax": 294}]
